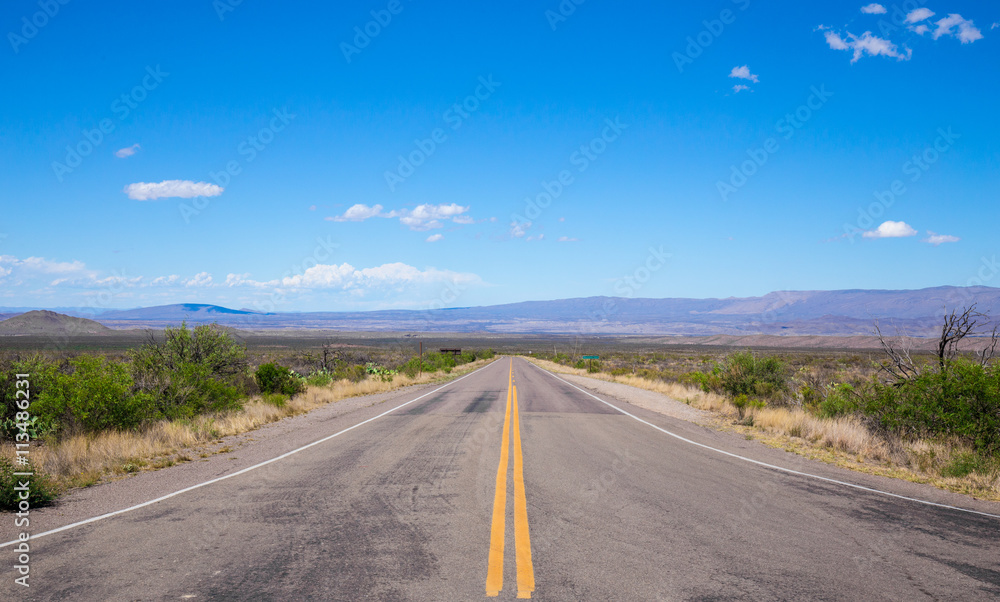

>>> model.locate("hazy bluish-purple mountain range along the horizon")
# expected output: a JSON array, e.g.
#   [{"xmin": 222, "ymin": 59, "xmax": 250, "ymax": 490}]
[{"xmin": 0, "ymin": 286, "xmax": 1000, "ymax": 336}]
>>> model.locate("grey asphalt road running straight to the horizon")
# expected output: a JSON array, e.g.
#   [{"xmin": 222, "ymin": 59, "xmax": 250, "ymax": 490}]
[{"xmin": 0, "ymin": 358, "xmax": 1000, "ymax": 601}]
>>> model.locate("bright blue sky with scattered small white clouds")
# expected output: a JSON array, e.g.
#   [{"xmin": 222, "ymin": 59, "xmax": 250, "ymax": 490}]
[{"xmin": 0, "ymin": 0, "xmax": 1000, "ymax": 311}]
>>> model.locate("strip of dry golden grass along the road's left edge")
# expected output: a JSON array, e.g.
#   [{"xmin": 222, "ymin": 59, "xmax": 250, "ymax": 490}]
[{"xmin": 0, "ymin": 360, "xmax": 492, "ymax": 488}]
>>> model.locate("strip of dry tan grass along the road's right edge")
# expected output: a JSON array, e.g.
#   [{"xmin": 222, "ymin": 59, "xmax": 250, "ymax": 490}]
[{"xmin": 530, "ymin": 359, "xmax": 1000, "ymax": 501}]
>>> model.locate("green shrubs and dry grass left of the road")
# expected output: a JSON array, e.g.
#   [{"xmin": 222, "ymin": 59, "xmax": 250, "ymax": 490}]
[{"xmin": 0, "ymin": 325, "xmax": 494, "ymax": 509}]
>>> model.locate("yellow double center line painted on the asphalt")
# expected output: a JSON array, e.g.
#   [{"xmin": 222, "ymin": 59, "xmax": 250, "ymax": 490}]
[{"xmin": 486, "ymin": 359, "xmax": 535, "ymax": 598}]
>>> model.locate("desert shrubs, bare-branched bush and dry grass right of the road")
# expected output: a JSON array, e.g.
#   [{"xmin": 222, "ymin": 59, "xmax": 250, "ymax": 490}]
[{"xmin": 540, "ymin": 306, "xmax": 1000, "ymax": 500}]
